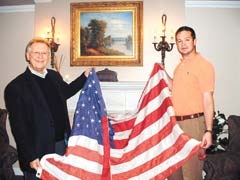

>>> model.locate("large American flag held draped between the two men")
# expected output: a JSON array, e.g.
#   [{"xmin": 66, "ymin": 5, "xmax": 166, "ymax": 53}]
[{"xmin": 37, "ymin": 63, "xmax": 200, "ymax": 180}]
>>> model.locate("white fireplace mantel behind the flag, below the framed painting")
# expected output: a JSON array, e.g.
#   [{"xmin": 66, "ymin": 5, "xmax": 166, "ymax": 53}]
[{"xmin": 67, "ymin": 81, "xmax": 146, "ymax": 114}]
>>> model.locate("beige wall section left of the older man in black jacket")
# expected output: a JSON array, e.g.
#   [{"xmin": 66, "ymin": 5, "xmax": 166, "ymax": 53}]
[{"xmin": 0, "ymin": 8, "xmax": 34, "ymax": 173}]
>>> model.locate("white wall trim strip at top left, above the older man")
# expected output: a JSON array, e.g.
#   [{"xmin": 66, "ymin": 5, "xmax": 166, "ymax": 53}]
[{"xmin": 0, "ymin": 5, "xmax": 35, "ymax": 13}]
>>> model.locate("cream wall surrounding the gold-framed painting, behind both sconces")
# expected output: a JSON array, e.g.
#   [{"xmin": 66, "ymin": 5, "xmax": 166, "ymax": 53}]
[{"xmin": 32, "ymin": 0, "xmax": 185, "ymax": 81}]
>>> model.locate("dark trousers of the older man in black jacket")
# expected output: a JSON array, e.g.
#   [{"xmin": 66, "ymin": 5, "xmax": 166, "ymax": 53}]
[{"xmin": 23, "ymin": 140, "xmax": 66, "ymax": 180}]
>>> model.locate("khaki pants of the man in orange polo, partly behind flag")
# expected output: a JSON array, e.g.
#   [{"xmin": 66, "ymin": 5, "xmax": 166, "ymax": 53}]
[{"xmin": 168, "ymin": 116, "xmax": 205, "ymax": 180}]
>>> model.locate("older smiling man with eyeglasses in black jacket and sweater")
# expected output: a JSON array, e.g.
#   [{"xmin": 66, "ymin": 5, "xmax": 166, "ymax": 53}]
[{"xmin": 4, "ymin": 38, "xmax": 91, "ymax": 180}]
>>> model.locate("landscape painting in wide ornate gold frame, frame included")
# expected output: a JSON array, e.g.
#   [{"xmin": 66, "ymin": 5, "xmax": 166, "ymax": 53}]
[{"xmin": 70, "ymin": 1, "xmax": 143, "ymax": 66}]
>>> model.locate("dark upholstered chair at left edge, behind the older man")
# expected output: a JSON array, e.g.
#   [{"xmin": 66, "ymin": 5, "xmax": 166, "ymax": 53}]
[{"xmin": 0, "ymin": 109, "xmax": 18, "ymax": 180}]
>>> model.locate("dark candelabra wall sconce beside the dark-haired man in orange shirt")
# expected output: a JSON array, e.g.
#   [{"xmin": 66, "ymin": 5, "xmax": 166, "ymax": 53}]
[{"xmin": 153, "ymin": 14, "xmax": 174, "ymax": 66}]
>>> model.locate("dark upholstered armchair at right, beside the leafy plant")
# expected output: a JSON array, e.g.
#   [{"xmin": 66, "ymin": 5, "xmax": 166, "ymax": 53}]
[{"xmin": 203, "ymin": 115, "xmax": 240, "ymax": 180}]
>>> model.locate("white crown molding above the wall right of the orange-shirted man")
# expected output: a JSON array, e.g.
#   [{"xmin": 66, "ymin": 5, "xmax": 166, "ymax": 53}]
[{"xmin": 185, "ymin": 1, "xmax": 240, "ymax": 8}]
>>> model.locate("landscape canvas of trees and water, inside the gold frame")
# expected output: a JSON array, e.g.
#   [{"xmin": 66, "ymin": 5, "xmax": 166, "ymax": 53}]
[{"xmin": 80, "ymin": 12, "xmax": 133, "ymax": 56}]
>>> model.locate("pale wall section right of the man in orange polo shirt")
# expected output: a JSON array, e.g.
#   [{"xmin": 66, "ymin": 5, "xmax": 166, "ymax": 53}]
[{"xmin": 186, "ymin": 6, "xmax": 240, "ymax": 116}]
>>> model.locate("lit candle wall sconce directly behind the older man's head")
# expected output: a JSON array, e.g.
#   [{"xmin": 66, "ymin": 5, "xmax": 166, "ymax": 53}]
[{"xmin": 46, "ymin": 17, "xmax": 60, "ymax": 68}]
